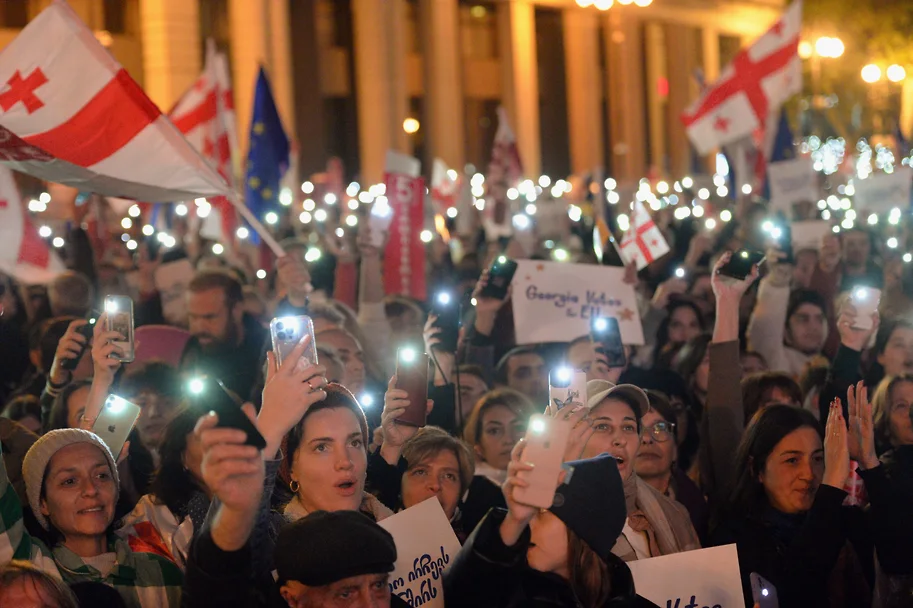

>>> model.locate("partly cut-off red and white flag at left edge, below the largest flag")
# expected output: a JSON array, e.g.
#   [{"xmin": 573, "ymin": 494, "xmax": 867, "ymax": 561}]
[{"xmin": 0, "ymin": 165, "xmax": 66, "ymax": 284}]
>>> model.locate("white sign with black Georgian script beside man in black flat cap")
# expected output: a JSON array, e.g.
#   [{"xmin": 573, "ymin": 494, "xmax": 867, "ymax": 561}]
[{"xmin": 380, "ymin": 498, "xmax": 460, "ymax": 608}]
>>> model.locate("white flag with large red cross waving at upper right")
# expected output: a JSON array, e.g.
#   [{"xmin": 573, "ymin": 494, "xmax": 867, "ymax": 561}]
[{"xmin": 682, "ymin": 0, "xmax": 802, "ymax": 154}]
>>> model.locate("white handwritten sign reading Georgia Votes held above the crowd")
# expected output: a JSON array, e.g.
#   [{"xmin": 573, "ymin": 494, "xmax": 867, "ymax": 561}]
[{"xmin": 511, "ymin": 260, "xmax": 644, "ymax": 344}]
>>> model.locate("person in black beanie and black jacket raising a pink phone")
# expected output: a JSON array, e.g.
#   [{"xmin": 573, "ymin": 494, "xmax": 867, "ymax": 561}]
[{"xmin": 444, "ymin": 454, "xmax": 654, "ymax": 608}]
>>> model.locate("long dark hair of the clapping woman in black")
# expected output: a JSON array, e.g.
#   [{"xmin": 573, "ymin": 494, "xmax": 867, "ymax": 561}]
[{"xmin": 717, "ymin": 404, "xmax": 823, "ymax": 523}]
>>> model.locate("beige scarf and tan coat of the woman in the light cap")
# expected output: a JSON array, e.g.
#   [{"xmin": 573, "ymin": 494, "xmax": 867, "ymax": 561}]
[{"xmin": 612, "ymin": 473, "xmax": 700, "ymax": 562}]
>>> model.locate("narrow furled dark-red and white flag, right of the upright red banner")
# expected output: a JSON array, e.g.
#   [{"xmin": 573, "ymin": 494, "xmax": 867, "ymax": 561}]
[{"xmin": 483, "ymin": 107, "xmax": 523, "ymax": 241}]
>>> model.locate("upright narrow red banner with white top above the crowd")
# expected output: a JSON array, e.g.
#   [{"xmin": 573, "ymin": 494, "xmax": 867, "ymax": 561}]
[{"xmin": 384, "ymin": 152, "xmax": 426, "ymax": 300}]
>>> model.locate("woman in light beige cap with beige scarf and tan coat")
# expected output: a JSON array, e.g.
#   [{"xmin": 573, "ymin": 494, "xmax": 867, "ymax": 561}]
[{"xmin": 583, "ymin": 380, "xmax": 701, "ymax": 562}]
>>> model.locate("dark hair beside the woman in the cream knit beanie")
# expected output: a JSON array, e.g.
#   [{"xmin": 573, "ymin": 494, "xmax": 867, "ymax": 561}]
[{"xmin": 149, "ymin": 405, "xmax": 203, "ymax": 519}]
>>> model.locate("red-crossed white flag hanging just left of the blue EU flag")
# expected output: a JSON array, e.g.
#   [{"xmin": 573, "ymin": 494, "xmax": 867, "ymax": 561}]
[{"xmin": 169, "ymin": 39, "xmax": 240, "ymax": 238}]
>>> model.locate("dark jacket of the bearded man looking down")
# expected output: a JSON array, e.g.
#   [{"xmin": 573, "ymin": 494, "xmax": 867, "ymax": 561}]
[{"xmin": 181, "ymin": 313, "xmax": 269, "ymax": 401}]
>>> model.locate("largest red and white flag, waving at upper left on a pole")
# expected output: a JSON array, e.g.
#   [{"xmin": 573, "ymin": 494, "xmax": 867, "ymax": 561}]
[{"xmin": 0, "ymin": 0, "xmax": 230, "ymax": 202}]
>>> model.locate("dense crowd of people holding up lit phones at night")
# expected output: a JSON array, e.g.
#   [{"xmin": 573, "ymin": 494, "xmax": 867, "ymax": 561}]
[{"xmin": 0, "ymin": 190, "xmax": 913, "ymax": 608}]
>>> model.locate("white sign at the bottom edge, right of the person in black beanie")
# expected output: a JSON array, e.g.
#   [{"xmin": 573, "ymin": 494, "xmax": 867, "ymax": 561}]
[{"xmin": 628, "ymin": 545, "xmax": 745, "ymax": 608}]
